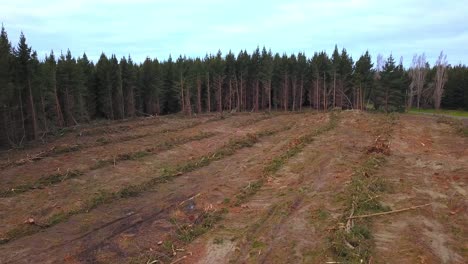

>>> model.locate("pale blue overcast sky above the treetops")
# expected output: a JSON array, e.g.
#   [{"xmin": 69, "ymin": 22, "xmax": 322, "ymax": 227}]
[{"xmin": 0, "ymin": 0, "xmax": 468, "ymax": 65}]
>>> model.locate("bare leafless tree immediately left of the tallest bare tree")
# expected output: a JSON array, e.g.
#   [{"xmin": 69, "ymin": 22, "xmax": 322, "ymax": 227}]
[{"xmin": 407, "ymin": 53, "xmax": 427, "ymax": 109}]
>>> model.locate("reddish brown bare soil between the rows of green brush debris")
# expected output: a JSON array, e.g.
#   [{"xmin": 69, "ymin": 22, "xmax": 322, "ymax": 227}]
[{"xmin": 0, "ymin": 112, "xmax": 468, "ymax": 263}]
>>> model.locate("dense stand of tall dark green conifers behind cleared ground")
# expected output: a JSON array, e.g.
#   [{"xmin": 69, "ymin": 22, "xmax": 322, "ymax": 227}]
[{"xmin": 0, "ymin": 27, "xmax": 468, "ymax": 147}]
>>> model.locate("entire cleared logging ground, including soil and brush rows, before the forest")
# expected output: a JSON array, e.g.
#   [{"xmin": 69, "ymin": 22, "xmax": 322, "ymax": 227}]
[{"xmin": 0, "ymin": 111, "xmax": 468, "ymax": 264}]
